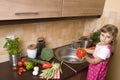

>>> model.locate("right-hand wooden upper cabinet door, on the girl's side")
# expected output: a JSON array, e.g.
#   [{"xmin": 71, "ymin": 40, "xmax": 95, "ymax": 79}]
[{"xmin": 62, "ymin": 0, "xmax": 105, "ymax": 17}]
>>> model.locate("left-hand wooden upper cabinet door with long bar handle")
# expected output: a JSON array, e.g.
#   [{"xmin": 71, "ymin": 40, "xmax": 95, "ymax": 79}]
[{"xmin": 0, "ymin": 0, "xmax": 62, "ymax": 20}]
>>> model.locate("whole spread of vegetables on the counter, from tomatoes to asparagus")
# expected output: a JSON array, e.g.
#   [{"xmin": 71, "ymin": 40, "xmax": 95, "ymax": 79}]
[{"xmin": 12, "ymin": 53, "xmax": 62, "ymax": 80}]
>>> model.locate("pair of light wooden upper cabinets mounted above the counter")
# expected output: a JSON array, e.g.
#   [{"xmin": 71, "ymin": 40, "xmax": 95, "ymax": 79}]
[{"xmin": 0, "ymin": 0, "xmax": 105, "ymax": 20}]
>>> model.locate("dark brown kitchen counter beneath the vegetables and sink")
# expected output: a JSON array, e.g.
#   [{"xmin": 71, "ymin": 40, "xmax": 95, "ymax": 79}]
[{"xmin": 0, "ymin": 58, "xmax": 88, "ymax": 80}]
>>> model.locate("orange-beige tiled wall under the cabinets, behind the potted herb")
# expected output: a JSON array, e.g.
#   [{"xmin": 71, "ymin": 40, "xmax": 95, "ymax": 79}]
[{"xmin": 0, "ymin": 19, "xmax": 84, "ymax": 62}]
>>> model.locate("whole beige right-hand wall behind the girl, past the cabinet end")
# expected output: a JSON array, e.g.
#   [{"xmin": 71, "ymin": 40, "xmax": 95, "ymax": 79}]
[{"xmin": 84, "ymin": 0, "xmax": 120, "ymax": 80}]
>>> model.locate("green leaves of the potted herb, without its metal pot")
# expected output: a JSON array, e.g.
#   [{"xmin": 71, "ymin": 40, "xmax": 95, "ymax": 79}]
[{"xmin": 4, "ymin": 37, "xmax": 20, "ymax": 55}]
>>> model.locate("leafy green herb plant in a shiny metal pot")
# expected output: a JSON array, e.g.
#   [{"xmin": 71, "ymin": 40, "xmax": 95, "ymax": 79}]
[{"xmin": 4, "ymin": 36, "xmax": 21, "ymax": 66}]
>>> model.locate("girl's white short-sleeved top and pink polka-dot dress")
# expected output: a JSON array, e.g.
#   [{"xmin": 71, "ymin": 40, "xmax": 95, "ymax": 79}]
[{"xmin": 86, "ymin": 43, "xmax": 112, "ymax": 80}]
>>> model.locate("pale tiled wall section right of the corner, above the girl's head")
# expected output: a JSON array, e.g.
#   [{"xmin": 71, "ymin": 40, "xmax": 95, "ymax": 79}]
[{"xmin": 84, "ymin": 11, "xmax": 120, "ymax": 35}]
